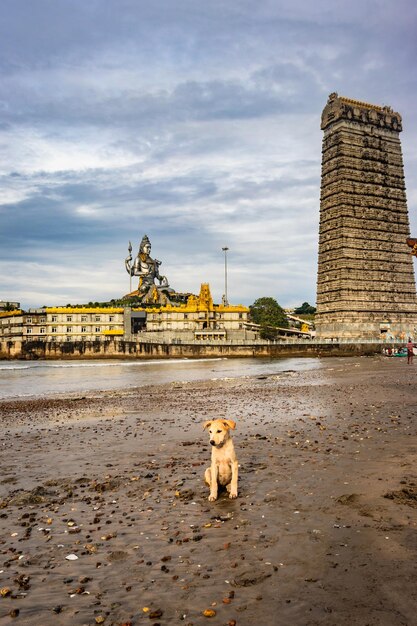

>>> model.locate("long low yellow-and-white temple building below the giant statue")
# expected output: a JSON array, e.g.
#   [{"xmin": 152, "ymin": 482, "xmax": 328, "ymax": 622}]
[{"xmin": 0, "ymin": 283, "xmax": 250, "ymax": 343}]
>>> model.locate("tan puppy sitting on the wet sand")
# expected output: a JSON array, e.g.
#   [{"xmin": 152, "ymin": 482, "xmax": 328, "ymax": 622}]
[{"xmin": 203, "ymin": 419, "xmax": 238, "ymax": 502}]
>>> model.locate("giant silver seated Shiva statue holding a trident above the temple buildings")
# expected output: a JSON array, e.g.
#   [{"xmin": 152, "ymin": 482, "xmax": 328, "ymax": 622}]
[{"xmin": 125, "ymin": 235, "xmax": 177, "ymax": 305}]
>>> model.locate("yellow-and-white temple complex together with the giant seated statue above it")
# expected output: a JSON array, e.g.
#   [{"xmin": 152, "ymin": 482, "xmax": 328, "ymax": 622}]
[{"xmin": 0, "ymin": 235, "xmax": 250, "ymax": 353}]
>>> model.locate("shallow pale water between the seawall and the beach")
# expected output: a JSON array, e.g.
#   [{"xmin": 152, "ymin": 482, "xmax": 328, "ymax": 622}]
[{"xmin": 0, "ymin": 358, "xmax": 322, "ymax": 399}]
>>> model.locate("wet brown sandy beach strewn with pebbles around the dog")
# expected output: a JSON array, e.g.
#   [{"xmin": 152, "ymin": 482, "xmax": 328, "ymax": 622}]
[{"xmin": 0, "ymin": 357, "xmax": 417, "ymax": 626}]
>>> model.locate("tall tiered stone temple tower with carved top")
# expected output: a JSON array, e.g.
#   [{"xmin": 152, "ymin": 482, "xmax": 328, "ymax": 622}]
[{"xmin": 316, "ymin": 93, "xmax": 417, "ymax": 340}]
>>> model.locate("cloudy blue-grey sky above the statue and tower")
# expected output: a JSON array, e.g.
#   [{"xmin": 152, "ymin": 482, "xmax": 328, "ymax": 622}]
[{"xmin": 0, "ymin": 0, "xmax": 417, "ymax": 308}]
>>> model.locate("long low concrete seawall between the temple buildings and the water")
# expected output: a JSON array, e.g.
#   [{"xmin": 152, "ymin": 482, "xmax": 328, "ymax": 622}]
[{"xmin": 0, "ymin": 340, "xmax": 383, "ymax": 360}]
